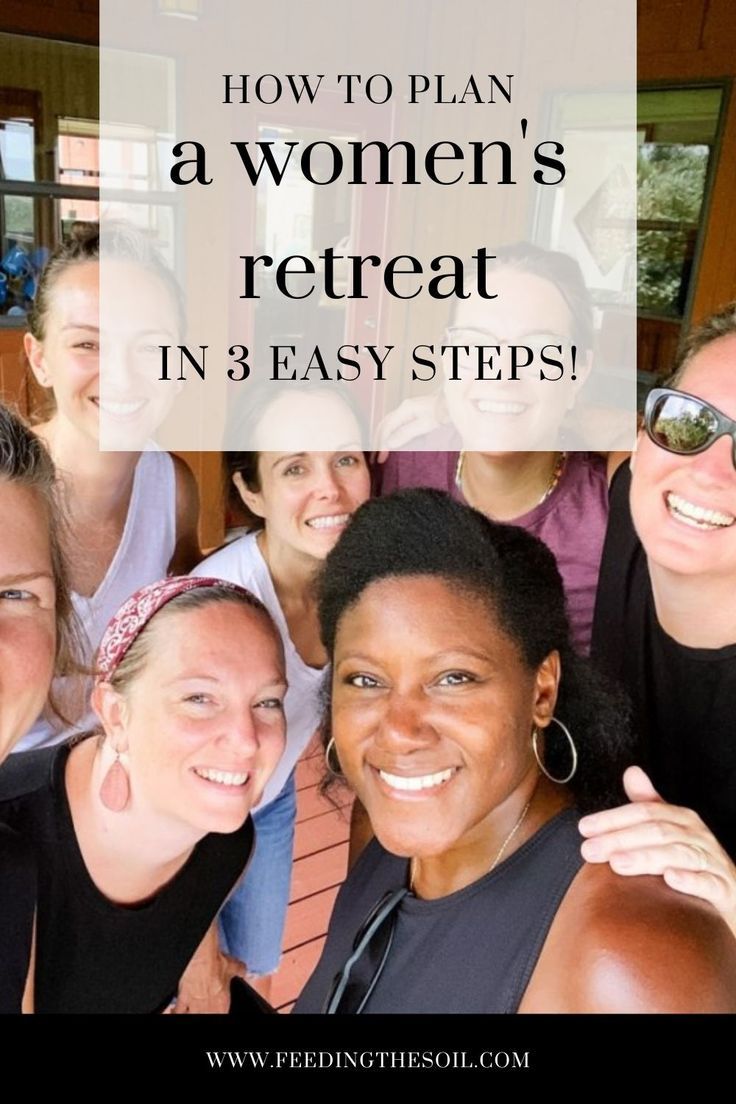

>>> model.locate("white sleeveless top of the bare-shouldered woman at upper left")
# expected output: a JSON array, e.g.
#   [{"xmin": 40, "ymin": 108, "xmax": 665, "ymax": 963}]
[{"xmin": 13, "ymin": 452, "xmax": 177, "ymax": 752}]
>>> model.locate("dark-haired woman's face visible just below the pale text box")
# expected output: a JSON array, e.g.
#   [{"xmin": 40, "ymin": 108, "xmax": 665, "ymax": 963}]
[{"xmin": 239, "ymin": 449, "xmax": 371, "ymax": 560}]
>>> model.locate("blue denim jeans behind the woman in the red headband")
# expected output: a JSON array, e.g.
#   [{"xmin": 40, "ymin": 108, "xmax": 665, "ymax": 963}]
[{"xmin": 220, "ymin": 772, "xmax": 297, "ymax": 974}]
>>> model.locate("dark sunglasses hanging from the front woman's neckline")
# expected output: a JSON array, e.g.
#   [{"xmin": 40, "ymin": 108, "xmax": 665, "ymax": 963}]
[{"xmin": 322, "ymin": 889, "xmax": 408, "ymax": 1016}]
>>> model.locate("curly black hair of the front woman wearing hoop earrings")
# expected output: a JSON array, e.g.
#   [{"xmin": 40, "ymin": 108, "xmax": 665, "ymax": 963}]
[{"xmin": 318, "ymin": 490, "xmax": 633, "ymax": 813}]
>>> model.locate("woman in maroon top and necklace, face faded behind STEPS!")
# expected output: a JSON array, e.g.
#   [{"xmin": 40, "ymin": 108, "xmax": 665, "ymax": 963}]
[{"xmin": 376, "ymin": 242, "xmax": 608, "ymax": 654}]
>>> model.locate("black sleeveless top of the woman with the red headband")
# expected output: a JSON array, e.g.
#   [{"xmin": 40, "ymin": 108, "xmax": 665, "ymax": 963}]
[{"xmin": 0, "ymin": 744, "xmax": 254, "ymax": 1012}]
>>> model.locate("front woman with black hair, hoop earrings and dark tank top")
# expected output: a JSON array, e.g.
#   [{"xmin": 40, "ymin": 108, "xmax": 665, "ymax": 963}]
[{"xmin": 297, "ymin": 490, "xmax": 736, "ymax": 1012}]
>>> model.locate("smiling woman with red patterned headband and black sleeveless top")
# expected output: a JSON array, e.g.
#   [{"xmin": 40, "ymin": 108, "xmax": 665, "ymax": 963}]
[{"xmin": 0, "ymin": 576, "xmax": 286, "ymax": 1012}]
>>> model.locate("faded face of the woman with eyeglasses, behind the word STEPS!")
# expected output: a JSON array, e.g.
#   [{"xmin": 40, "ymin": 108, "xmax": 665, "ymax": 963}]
[{"xmin": 445, "ymin": 268, "xmax": 587, "ymax": 452}]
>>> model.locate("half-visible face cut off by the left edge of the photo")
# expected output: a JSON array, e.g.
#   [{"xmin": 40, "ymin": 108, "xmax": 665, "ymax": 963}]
[{"xmin": 0, "ymin": 480, "xmax": 56, "ymax": 761}]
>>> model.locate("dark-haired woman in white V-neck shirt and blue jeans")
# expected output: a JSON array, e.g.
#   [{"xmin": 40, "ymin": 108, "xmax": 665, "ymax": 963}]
[{"xmin": 194, "ymin": 389, "xmax": 370, "ymax": 996}]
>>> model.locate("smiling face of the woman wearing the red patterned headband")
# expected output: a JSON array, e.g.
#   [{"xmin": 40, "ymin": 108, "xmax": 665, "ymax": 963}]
[{"xmin": 95, "ymin": 602, "xmax": 286, "ymax": 838}]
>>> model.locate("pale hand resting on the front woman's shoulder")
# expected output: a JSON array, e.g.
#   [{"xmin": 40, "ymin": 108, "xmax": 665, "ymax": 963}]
[{"xmin": 579, "ymin": 767, "xmax": 736, "ymax": 935}]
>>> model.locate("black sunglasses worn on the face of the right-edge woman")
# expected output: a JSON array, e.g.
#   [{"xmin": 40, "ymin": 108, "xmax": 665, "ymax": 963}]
[{"xmin": 644, "ymin": 388, "xmax": 736, "ymax": 468}]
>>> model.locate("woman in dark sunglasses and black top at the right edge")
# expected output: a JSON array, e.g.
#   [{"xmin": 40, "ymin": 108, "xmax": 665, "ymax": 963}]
[{"xmin": 582, "ymin": 304, "xmax": 736, "ymax": 933}]
